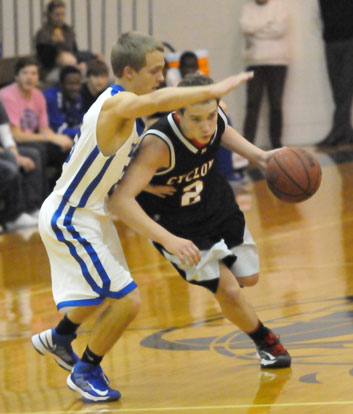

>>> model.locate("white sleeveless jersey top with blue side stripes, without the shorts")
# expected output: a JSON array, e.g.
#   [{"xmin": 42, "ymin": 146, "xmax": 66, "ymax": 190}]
[{"xmin": 53, "ymin": 85, "xmax": 142, "ymax": 212}]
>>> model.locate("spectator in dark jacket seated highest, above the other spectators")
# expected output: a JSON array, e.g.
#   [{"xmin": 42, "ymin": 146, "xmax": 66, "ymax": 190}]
[{"xmin": 35, "ymin": 0, "xmax": 95, "ymax": 80}]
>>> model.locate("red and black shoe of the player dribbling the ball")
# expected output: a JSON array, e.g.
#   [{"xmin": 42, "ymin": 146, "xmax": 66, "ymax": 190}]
[{"xmin": 256, "ymin": 330, "xmax": 292, "ymax": 368}]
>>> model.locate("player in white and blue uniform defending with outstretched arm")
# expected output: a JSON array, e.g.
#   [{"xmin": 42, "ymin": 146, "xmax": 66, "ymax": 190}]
[{"xmin": 32, "ymin": 32, "xmax": 252, "ymax": 402}]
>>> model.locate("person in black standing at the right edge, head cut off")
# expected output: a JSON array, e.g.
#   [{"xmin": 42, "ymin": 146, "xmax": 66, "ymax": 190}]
[{"xmin": 318, "ymin": 0, "xmax": 353, "ymax": 147}]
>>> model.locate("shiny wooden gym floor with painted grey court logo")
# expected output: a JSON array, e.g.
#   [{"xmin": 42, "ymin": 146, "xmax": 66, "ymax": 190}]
[{"xmin": 0, "ymin": 148, "xmax": 353, "ymax": 414}]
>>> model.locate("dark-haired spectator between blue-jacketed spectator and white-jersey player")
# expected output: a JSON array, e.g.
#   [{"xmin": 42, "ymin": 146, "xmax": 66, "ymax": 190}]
[{"xmin": 81, "ymin": 59, "xmax": 109, "ymax": 112}]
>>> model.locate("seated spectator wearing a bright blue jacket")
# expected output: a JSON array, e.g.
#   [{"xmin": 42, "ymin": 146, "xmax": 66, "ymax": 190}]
[{"xmin": 44, "ymin": 66, "xmax": 84, "ymax": 139}]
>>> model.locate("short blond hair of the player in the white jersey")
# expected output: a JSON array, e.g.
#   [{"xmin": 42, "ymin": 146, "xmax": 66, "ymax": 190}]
[{"xmin": 110, "ymin": 32, "xmax": 164, "ymax": 78}]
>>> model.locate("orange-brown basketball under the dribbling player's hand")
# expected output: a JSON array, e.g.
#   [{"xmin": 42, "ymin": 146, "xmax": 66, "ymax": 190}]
[{"xmin": 266, "ymin": 147, "xmax": 321, "ymax": 203}]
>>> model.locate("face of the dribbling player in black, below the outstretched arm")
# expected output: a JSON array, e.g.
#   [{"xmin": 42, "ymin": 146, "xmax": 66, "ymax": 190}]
[{"xmin": 179, "ymin": 99, "xmax": 218, "ymax": 145}]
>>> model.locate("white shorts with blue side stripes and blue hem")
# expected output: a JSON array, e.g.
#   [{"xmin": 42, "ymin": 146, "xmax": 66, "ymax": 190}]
[{"xmin": 39, "ymin": 194, "xmax": 137, "ymax": 312}]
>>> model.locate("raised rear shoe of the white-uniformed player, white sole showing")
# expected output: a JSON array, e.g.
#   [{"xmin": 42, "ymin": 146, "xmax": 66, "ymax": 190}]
[{"xmin": 32, "ymin": 329, "xmax": 79, "ymax": 371}]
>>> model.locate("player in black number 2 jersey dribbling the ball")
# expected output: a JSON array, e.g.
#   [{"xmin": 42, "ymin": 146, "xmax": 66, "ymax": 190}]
[{"xmin": 111, "ymin": 75, "xmax": 291, "ymax": 368}]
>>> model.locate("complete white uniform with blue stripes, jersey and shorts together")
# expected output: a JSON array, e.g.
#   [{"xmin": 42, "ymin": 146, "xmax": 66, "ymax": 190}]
[{"xmin": 39, "ymin": 85, "xmax": 143, "ymax": 312}]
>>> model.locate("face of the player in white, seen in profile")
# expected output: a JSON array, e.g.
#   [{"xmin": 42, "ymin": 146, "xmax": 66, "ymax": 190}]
[{"xmin": 132, "ymin": 50, "xmax": 164, "ymax": 95}]
